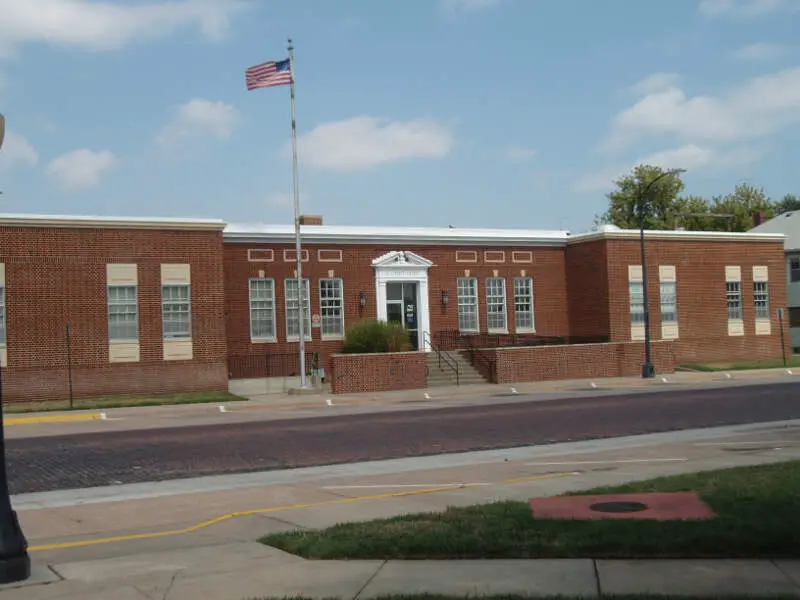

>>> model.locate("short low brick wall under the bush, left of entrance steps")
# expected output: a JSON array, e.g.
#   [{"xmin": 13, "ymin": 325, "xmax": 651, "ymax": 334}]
[{"xmin": 329, "ymin": 352, "xmax": 428, "ymax": 394}]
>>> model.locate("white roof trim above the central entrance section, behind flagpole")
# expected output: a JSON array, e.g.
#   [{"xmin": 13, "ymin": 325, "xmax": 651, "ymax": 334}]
[{"xmin": 223, "ymin": 224, "xmax": 569, "ymax": 246}]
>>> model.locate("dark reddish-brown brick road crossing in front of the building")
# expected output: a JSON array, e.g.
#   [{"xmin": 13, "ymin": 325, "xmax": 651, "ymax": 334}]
[{"xmin": 7, "ymin": 382, "xmax": 800, "ymax": 494}]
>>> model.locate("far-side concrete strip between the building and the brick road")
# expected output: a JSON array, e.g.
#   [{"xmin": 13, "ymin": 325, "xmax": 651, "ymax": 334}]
[{"xmin": 6, "ymin": 368, "xmax": 800, "ymax": 437}]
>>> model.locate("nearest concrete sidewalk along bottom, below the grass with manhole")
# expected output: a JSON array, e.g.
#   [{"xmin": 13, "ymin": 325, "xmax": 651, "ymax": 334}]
[{"xmin": 2, "ymin": 543, "xmax": 800, "ymax": 600}]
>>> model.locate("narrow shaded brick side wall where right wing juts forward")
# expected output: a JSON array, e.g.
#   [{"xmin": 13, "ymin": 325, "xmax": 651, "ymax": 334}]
[{"xmin": 566, "ymin": 241, "xmax": 611, "ymax": 337}]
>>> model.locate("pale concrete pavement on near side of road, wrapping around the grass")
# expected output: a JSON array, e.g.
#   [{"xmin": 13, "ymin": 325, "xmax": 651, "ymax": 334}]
[{"xmin": 0, "ymin": 421, "xmax": 800, "ymax": 600}]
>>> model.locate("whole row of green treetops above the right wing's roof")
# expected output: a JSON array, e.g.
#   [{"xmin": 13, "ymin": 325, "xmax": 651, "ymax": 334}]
[{"xmin": 595, "ymin": 165, "xmax": 800, "ymax": 231}]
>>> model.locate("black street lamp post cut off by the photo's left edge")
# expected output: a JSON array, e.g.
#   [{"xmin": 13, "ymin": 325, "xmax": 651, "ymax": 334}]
[{"xmin": 0, "ymin": 113, "xmax": 31, "ymax": 584}]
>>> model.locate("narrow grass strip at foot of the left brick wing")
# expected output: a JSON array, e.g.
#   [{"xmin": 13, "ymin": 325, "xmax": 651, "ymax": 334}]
[{"xmin": 3, "ymin": 392, "xmax": 244, "ymax": 414}]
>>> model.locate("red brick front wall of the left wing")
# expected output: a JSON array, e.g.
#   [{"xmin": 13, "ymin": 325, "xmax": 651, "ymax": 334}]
[{"xmin": 0, "ymin": 227, "xmax": 227, "ymax": 401}]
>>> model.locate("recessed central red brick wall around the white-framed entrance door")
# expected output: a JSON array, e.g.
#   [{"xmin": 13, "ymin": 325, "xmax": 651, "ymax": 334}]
[{"xmin": 220, "ymin": 242, "xmax": 569, "ymax": 376}]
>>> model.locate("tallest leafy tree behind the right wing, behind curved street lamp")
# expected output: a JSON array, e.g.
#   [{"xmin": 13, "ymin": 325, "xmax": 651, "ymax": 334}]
[{"xmin": 597, "ymin": 165, "xmax": 688, "ymax": 229}]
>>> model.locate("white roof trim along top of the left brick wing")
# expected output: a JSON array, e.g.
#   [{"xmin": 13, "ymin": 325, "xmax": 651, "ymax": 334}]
[{"xmin": 0, "ymin": 213, "xmax": 225, "ymax": 231}]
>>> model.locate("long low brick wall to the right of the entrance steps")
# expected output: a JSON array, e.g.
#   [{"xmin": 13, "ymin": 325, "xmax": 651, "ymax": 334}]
[{"xmin": 476, "ymin": 341, "xmax": 675, "ymax": 383}]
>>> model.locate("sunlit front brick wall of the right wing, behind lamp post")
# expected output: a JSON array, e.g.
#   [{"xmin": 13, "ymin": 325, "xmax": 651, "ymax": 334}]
[{"xmin": 605, "ymin": 240, "xmax": 786, "ymax": 364}]
